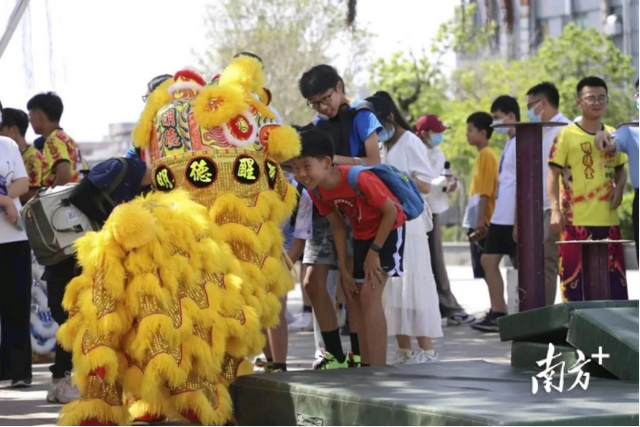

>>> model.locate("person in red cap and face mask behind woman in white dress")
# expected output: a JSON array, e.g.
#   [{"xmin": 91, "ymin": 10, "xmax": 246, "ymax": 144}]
[{"xmin": 414, "ymin": 114, "xmax": 476, "ymax": 326}]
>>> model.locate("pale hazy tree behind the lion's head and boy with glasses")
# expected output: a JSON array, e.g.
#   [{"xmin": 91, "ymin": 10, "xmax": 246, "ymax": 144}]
[{"xmin": 199, "ymin": 0, "xmax": 370, "ymax": 124}]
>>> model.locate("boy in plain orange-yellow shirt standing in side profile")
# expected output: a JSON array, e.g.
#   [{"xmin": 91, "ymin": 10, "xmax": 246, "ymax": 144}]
[{"xmin": 463, "ymin": 112, "xmax": 498, "ymax": 279}]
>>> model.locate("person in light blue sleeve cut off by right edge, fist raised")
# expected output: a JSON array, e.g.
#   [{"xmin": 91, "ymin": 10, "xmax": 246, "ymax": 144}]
[{"xmin": 596, "ymin": 79, "xmax": 640, "ymax": 265}]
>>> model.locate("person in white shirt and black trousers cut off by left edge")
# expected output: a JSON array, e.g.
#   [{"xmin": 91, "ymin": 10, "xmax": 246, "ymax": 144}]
[{"xmin": 0, "ymin": 128, "xmax": 32, "ymax": 387}]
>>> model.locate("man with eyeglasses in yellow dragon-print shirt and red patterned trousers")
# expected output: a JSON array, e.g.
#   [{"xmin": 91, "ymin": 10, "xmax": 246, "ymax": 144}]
[{"xmin": 547, "ymin": 77, "xmax": 629, "ymax": 302}]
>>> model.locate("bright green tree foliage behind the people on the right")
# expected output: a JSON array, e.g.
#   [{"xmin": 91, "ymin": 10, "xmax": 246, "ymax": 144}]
[{"xmin": 369, "ymin": 4, "xmax": 634, "ymax": 241}]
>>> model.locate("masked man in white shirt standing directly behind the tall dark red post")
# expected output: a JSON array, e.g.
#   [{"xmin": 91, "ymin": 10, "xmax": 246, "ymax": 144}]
[{"xmin": 527, "ymin": 82, "xmax": 571, "ymax": 305}]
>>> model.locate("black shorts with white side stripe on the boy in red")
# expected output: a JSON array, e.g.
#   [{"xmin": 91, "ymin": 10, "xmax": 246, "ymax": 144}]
[{"xmin": 353, "ymin": 225, "xmax": 405, "ymax": 283}]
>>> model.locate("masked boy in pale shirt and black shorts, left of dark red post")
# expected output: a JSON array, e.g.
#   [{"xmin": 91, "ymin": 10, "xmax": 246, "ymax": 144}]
[{"xmin": 471, "ymin": 95, "xmax": 520, "ymax": 332}]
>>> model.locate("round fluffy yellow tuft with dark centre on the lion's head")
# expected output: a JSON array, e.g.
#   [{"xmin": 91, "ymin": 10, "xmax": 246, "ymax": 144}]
[{"xmin": 192, "ymin": 84, "xmax": 249, "ymax": 129}]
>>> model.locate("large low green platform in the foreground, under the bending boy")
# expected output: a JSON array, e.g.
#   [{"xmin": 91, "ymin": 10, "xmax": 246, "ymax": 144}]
[{"xmin": 231, "ymin": 361, "xmax": 640, "ymax": 427}]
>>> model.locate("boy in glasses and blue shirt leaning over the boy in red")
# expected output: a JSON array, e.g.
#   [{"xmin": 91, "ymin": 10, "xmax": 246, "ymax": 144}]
[{"xmin": 298, "ymin": 64, "xmax": 382, "ymax": 369}]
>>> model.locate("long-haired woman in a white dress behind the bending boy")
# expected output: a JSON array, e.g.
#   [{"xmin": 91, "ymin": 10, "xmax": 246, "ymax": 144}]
[{"xmin": 367, "ymin": 92, "xmax": 442, "ymax": 364}]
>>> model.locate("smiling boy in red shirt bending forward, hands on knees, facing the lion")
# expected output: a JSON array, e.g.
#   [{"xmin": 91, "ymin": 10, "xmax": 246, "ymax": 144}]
[{"xmin": 293, "ymin": 129, "xmax": 406, "ymax": 366}]
